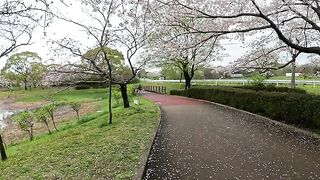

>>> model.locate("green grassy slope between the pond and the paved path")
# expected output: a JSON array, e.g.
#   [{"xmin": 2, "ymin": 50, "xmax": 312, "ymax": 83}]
[{"xmin": 0, "ymin": 89, "xmax": 159, "ymax": 179}]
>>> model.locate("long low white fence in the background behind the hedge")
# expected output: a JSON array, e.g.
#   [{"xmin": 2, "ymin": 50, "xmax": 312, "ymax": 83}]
[{"xmin": 144, "ymin": 79, "xmax": 320, "ymax": 87}]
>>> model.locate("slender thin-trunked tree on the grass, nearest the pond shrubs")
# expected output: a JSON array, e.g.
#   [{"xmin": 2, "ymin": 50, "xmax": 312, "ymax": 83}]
[{"xmin": 52, "ymin": 0, "xmax": 126, "ymax": 124}]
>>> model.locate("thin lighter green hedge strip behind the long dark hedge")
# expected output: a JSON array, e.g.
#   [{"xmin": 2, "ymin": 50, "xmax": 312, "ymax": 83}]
[{"xmin": 234, "ymin": 85, "xmax": 307, "ymax": 94}]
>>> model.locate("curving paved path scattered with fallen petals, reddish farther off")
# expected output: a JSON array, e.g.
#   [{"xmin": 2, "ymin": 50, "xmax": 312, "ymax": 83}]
[{"xmin": 144, "ymin": 93, "xmax": 320, "ymax": 180}]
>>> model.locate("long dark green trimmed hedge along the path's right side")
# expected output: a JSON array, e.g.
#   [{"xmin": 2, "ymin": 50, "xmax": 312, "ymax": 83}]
[{"xmin": 170, "ymin": 87, "xmax": 320, "ymax": 128}]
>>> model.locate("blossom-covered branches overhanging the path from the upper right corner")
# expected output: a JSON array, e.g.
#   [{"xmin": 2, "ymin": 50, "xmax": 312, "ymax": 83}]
[{"xmin": 161, "ymin": 0, "xmax": 320, "ymax": 55}]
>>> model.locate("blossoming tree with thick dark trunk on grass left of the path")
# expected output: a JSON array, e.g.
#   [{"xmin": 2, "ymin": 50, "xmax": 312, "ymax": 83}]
[{"xmin": 113, "ymin": 1, "xmax": 154, "ymax": 108}]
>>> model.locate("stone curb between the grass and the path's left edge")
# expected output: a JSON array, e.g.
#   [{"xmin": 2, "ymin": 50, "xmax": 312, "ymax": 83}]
[{"xmin": 132, "ymin": 102, "xmax": 163, "ymax": 180}]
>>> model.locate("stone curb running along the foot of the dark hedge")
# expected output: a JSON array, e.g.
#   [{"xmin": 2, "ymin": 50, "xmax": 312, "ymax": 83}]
[{"xmin": 177, "ymin": 96, "xmax": 320, "ymax": 140}]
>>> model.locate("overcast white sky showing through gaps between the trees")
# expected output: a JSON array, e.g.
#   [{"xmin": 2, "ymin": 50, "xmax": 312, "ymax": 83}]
[{"xmin": 0, "ymin": 1, "xmax": 312, "ymax": 68}]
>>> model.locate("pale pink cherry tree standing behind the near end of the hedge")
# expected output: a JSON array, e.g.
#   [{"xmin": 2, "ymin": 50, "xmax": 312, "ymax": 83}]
[{"xmin": 149, "ymin": 2, "xmax": 221, "ymax": 89}]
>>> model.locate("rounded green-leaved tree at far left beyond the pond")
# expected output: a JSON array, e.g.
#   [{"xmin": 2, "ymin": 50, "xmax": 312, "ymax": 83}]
[{"xmin": 1, "ymin": 51, "xmax": 45, "ymax": 90}]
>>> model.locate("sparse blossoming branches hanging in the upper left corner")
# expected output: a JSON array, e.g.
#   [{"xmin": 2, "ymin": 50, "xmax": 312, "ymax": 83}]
[{"xmin": 0, "ymin": 0, "xmax": 51, "ymax": 58}]
